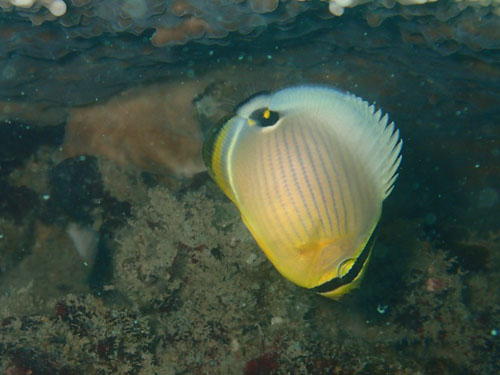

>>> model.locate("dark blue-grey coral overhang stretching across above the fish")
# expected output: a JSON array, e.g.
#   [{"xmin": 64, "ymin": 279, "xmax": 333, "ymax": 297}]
[{"xmin": 0, "ymin": 0, "xmax": 500, "ymax": 125}]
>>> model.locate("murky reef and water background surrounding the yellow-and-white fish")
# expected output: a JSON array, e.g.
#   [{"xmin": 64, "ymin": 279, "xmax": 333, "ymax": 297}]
[{"xmin": 0, "ymin": 0, "xmax": 500, "ymax": 375}]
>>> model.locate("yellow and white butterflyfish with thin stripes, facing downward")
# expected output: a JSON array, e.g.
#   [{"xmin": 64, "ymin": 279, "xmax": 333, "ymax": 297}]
[{"xmin": 203, "ymin": 85, "xmax": 403, "ymax": 299}]
